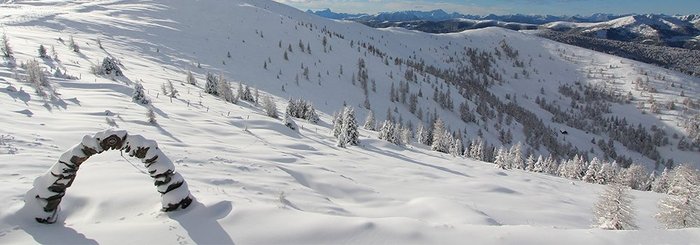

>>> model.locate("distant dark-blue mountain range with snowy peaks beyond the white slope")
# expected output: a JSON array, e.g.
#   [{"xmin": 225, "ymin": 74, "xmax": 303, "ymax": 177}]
[{"xmin": 307, "ymin": 9, "xmax": 700, "ymax": 50}]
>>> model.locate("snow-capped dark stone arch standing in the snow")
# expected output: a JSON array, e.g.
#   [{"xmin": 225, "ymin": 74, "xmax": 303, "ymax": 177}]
[{"xmin": 24, "ymin": 130, "xmax": 193, "ymax": 224}]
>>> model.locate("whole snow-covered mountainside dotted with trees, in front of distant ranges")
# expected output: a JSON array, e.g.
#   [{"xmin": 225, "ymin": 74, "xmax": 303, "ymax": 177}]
[{"xmin": 0, "ymin": 0, "xmax": 700, "ymax": 244}]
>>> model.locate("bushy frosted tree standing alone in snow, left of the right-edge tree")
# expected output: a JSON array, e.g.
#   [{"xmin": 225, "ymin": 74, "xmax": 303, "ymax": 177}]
[{"xmin": 594, "ymin": 184, "xmax": 637, "ymax": 230}]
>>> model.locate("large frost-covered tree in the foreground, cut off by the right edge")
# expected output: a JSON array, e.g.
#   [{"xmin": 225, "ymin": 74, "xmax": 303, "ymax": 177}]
[{"xmin": 656, "ymin": 164, "xmax": 700, "ymax": 229}]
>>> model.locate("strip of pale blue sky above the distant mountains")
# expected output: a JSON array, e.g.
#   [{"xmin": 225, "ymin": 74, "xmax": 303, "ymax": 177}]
[{"xmin": 275, "ymin": 0, "xmax": 700, "ymax": 15}]
